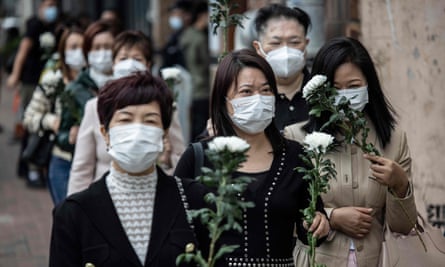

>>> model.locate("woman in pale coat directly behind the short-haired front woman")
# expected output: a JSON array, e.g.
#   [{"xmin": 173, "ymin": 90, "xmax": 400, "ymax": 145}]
[{"xmin": 68, "ymin": 31, "xmax": 184, "ymax": 195}]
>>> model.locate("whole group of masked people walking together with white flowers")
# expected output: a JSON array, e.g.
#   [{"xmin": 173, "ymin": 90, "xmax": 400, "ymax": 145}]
[{"xmin": 0, "ymin": 0, "xmax": 424, "ymax": 267}]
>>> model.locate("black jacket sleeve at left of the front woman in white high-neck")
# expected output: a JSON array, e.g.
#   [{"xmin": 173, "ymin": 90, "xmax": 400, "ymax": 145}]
[{"xmin": 49, "ymin": 202, "xmax": 81, "ymax": 267}]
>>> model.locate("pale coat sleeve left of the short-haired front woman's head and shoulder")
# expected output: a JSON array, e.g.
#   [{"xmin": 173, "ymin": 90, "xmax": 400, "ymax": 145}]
[{"xmin": 67, "ymin": 99, "xmax": 98, "ymax": 195}]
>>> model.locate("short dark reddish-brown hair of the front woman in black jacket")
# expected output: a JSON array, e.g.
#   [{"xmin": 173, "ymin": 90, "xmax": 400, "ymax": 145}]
[{"xmin": 97, "ymin": 71, "xmax": 173, "ymax": 130}]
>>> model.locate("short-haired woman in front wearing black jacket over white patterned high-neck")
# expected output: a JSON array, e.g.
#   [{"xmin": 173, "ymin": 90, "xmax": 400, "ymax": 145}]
[{"xmin": 49, "ymin": 72, "xmax": 205, "ymax": 267}]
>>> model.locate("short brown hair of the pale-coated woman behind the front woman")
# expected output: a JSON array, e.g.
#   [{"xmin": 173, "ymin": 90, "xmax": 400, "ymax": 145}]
[{"xmin": 113, "ymin": 30, "xmax": 153, "ymax": 63}]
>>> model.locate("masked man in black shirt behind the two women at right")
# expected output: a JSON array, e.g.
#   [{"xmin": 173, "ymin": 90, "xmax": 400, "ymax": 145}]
[{"xmin": 253, "ymin": 4, "xmax": 311, "ymax": 131}]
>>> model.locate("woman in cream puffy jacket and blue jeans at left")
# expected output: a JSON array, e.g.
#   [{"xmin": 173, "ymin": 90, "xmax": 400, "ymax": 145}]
[{"xmin": 23, "ymin": 25, "xmax": 85, "ymax": 198}]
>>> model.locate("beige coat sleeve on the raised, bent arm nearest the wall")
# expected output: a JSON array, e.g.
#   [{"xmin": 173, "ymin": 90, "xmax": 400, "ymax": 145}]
[{"xmin": 385, "ymin": 130, "xmax": 417, "ymax": 234}]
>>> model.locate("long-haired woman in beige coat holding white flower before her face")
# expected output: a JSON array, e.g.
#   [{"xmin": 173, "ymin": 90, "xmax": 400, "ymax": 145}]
[{"xmin": 285, "ymin": 37, "xmax": 417, "ymax": 267}]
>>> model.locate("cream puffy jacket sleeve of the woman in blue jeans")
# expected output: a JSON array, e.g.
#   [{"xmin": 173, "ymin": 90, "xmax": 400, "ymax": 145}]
[{"xmin": 23, "ymin": 86, "xmax": 58, "ymax": 132}]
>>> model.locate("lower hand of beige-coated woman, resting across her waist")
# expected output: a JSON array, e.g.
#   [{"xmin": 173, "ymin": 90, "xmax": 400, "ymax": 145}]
[{"xmin": 331, "ymin": 207, "xmax": 372, "ymax": 238}]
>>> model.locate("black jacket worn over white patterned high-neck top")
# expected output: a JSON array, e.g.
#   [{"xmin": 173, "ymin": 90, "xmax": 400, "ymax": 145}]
[{"xmin": 49, "ymin": 169, "xmax": 209, "ymax": 267}]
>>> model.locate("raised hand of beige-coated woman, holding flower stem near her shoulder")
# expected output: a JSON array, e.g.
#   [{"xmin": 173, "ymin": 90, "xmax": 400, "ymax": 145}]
[{"xmin": 364, "ymin": 154, "xmax": 408, "ymax": 197}]
